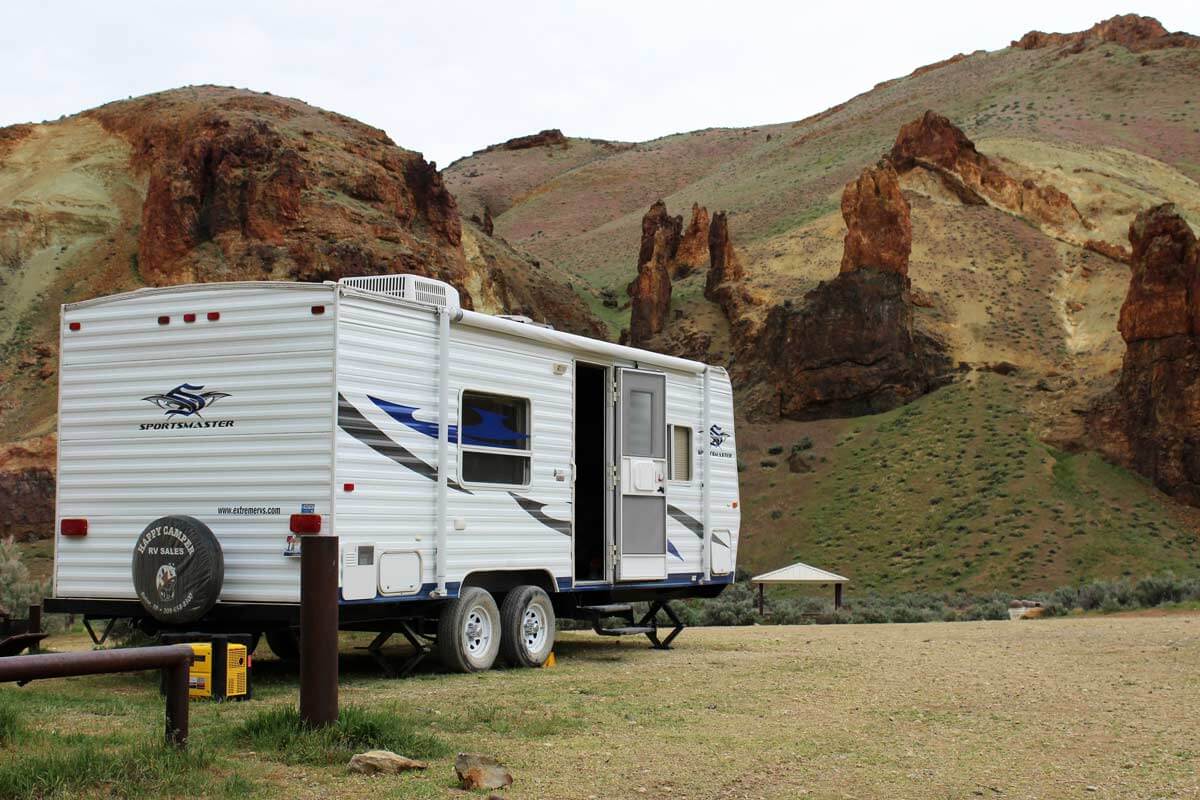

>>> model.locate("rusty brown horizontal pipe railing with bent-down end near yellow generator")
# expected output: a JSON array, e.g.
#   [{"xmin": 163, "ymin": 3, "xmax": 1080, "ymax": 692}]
[{"xmin": 0, "ymin": 644, "xmax": 192, "ymax": 747}]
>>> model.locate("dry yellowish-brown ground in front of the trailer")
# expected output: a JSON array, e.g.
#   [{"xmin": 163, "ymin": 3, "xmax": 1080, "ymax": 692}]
[{"xmin": 9, "ymin": 614, "xmax": 1200, "ymax": 800}]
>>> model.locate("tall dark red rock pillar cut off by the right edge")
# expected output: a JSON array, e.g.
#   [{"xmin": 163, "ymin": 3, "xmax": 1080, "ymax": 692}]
[{"xmin": 1088, "ymin": 204, "xmax": 1200, "ymax": 506}]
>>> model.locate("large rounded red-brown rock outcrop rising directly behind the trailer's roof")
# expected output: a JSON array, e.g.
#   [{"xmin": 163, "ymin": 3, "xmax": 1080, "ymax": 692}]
[{"xmin": 88, "ymin": 86, "xmax": 470, "ymax": 293}]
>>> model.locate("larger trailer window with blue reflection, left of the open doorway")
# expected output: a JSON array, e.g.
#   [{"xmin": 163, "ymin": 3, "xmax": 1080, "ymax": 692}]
[{"xmin": 458, "ymin": 392, "xmax": 532, "ymax": 486}]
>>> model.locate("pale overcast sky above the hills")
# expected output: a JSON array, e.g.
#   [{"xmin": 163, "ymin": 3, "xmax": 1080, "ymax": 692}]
[{"xmin": 7, "ymin": 0, "xmax": 1200, "ymax": 167}]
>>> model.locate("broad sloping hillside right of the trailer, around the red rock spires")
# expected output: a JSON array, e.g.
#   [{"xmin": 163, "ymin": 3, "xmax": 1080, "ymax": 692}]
[{"xmin": 445, "ymin": 10, "xmax": 1200, "ymax": 589}]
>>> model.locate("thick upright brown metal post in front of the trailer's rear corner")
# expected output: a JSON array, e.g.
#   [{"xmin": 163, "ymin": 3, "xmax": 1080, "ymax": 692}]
[{"xmin": 300, "ymin": 535, "xmax": 337, "ymax": 728}]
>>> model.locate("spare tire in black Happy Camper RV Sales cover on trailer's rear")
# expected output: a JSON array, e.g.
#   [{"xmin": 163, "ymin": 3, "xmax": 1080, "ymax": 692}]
[{"xmin": 133, "ymin": 516, "xmax": 224, "ymax": 624}]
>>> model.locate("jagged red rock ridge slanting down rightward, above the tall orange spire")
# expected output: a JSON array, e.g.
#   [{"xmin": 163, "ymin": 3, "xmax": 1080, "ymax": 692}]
[{"xmin": 890, "ymin": 112, "xmax": 1085, "ymax": 228}]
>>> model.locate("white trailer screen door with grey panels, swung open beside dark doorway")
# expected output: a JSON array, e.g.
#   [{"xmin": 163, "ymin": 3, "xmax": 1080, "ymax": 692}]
[{"xmin": 616, "ymin": 369, "xmax": 667, "ymax": 581}]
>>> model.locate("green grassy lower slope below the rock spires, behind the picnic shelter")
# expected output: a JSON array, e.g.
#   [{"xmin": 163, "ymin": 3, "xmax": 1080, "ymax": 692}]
[{"xmin": 739, "ymin": 373, "xmax": 1200, "ymax": 591}]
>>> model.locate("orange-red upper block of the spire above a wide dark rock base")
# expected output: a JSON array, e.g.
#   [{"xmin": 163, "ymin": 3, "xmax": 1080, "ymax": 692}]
[{"xmin": 841, "ymin": 160, "xmax": 912, "ymax": 275}]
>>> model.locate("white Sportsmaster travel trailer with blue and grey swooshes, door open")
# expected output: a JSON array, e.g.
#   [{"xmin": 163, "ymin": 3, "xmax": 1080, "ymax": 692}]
[{"xmin": 48, "ymin": 275, "xmax": 740, "ymax": 669}]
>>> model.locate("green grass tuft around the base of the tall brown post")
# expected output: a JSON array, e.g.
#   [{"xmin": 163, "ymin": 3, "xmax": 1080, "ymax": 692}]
[{"xmin": 234, "ymin": 706, "xmax": 450, "ymax": 764}]
